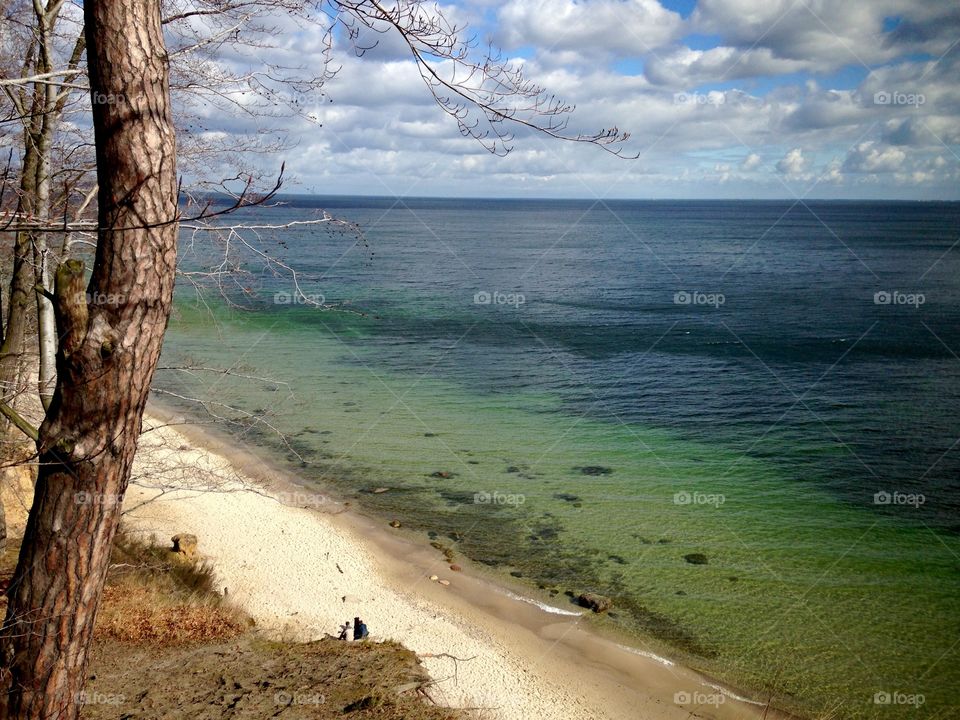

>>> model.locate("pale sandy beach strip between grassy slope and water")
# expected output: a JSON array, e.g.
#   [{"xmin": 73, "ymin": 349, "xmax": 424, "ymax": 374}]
[{"xmin": 125, "ymin": 404, "xmax": 793, "ymax": 720}]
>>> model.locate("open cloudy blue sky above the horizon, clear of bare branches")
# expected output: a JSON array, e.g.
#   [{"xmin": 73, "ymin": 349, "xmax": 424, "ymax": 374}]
[{"xmin": 189, "ymin": 0, "xmax": 960, "ymax": 200}]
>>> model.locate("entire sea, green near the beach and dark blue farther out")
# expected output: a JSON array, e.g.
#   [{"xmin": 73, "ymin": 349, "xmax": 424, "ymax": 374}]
[{"xmin": 154, "ymin": 196, "xmax": 960, "ymax": 718}]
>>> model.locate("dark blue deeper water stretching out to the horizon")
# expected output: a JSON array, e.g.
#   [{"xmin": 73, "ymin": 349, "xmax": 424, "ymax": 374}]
[{"xmin": 184, "ymin": 198, "xmax": 960, "ymax": 531}]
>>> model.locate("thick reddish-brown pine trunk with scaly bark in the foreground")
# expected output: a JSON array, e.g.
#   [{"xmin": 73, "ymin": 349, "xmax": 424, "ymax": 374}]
[{"xmin": 0, "ymin": 0, "xmax": 177, "ymax": 720}]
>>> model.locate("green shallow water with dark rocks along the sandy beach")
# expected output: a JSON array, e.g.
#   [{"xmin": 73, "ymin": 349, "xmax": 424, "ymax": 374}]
[{"xmin": 156, "ymin": 303, "xmax": 960, "ymax": 718}]
